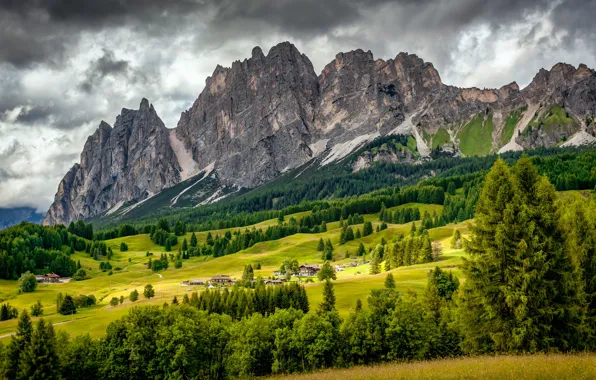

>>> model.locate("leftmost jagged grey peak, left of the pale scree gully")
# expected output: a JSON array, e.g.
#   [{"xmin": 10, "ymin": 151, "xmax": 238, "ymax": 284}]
[{"xmin": 44, "ymin": 99, "xmax": 180, "ymax": 224}]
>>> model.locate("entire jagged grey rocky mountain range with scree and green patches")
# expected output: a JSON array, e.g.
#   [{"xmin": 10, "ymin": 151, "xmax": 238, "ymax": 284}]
[{"xmin": 44, "ymin": 42, "xmax": 596, "ymax": 225}]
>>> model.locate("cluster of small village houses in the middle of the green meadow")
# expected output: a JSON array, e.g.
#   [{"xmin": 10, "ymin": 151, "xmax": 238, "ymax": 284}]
[{"xmin": 181, "ymin": 261, "xmax": 366, "ymax": 289}]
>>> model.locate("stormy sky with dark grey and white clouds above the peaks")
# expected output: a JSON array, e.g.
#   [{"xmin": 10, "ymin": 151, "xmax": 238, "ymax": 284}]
[{"xmin": 0, "ymin": 0, "xmax": 596, "ymax": 212}]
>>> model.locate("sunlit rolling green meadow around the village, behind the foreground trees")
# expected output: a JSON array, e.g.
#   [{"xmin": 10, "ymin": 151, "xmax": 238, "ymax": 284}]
[{"xmin": 0, "ymin": 203, "xmax": 466, "ymax": 339}]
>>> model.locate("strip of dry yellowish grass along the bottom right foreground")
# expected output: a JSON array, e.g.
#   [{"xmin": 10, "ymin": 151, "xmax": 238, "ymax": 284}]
[{"xmin": 274, "ymin": 354, "xmax": 596, "ymax": 380}]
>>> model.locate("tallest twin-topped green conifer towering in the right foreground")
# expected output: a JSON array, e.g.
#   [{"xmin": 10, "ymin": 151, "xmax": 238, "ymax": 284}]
[{"xmin": 460, "ymin": 158, "xmax": 582, "ymax": 352}]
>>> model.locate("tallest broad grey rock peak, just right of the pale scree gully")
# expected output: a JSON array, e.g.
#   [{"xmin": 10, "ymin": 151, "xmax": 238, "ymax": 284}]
[{"xmin": 176, "ymin": 43, "xmax": 319, "ymax": 187}]
